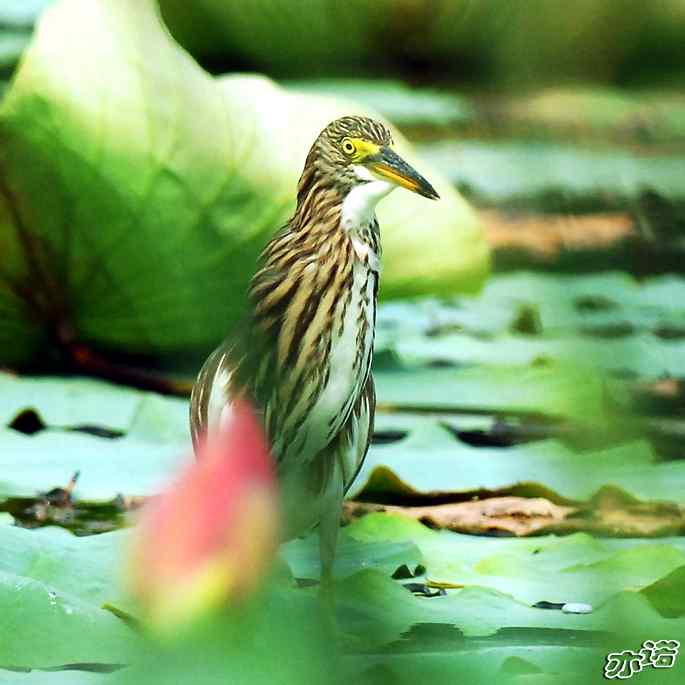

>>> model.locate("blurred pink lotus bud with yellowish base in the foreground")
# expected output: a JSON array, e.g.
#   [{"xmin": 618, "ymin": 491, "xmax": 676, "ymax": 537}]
[{"xmin": 129, "ymin": 400, "xmax": 279, "ymax": 628}]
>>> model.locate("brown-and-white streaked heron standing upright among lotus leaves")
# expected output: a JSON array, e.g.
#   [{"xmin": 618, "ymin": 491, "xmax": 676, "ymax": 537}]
[{"xmin": 191, "ymin": 116, "xmax": 438, "ymax": 587}]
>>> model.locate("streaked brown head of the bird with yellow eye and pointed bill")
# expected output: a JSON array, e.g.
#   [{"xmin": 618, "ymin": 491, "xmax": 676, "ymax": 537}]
[{"xmin": 299, "ymin": 116, "xmax": 439, "ymax": 210}]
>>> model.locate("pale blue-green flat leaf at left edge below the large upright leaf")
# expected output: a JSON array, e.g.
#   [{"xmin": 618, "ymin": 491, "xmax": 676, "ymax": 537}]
[{"xmin": 0, "ymin": 374, "xmax": 191, "ymax": 500}]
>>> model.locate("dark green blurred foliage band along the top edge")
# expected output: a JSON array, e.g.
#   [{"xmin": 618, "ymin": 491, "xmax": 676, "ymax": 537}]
[{"xmin": 162, "ymin": 0, "xmax": 685, "ymax": 90}]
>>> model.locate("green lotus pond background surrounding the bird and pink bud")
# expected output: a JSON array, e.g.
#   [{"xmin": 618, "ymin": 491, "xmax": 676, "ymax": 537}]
[{"xmin": 0, "ymin": 0, "xmax": 685, "ymax": 685}]
